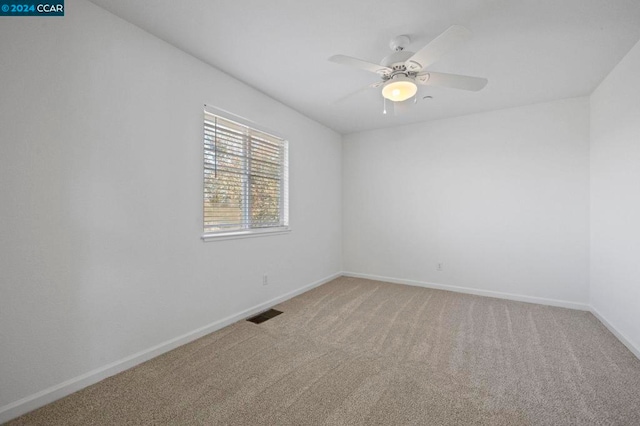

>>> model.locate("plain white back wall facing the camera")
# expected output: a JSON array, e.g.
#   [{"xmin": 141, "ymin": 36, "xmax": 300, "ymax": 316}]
[{"xmin": 342, "ymin": 98, "xmax": 589, "ymax": 308}]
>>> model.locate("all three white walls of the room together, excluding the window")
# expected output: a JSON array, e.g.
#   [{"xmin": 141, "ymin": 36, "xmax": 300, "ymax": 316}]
[{"xmin": 0, "ymin": 0, "xmax": 640, "ymax": 421}]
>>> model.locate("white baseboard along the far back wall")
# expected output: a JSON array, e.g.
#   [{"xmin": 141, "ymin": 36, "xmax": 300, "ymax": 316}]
[{"xmin": 342, "ymin": 272, "xmax": 590, "ymax": 311}]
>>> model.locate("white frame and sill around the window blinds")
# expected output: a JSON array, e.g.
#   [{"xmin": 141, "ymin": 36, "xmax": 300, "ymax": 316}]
[{"xmin": 201, "ymin": 105, "xmax": 291, "ymax": 242}]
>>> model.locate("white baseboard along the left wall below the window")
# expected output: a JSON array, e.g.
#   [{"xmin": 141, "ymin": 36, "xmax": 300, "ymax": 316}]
[{"xmin": 0, "ymin": 273, "xmax": 342, "ymax": 424}]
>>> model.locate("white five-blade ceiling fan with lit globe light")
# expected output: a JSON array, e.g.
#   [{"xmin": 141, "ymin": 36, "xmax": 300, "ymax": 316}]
[{"xmin": 329, "ymin": 25, "xmax": 487, "ymax": 113}]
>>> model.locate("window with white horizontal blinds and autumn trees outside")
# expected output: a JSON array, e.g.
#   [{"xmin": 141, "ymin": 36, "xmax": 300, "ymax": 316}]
[{"xmin": 203, "ymin": 111, "xmax": 289, "ymax": 239}]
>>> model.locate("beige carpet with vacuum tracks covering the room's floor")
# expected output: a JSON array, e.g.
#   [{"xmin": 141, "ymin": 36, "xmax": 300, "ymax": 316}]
[{"xmin": 11, "ymin": 278, "xmax": 640, "ymax": 425}]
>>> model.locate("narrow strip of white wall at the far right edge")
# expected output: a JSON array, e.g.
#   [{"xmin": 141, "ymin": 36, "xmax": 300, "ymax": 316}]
[{"xmin": 591, "ymin": 38, "xmax": 640, "ymax": 356}]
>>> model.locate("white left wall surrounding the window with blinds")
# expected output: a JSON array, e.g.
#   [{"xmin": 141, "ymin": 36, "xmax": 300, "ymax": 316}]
[{"xmin": 0, "ymin": 0, "xmax": 341, "ymax": 421}]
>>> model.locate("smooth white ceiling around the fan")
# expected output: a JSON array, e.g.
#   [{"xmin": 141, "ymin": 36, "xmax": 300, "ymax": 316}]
[{"xmin": 91, "ymin": 0, "xmax": 640, "ymax": 133}]
